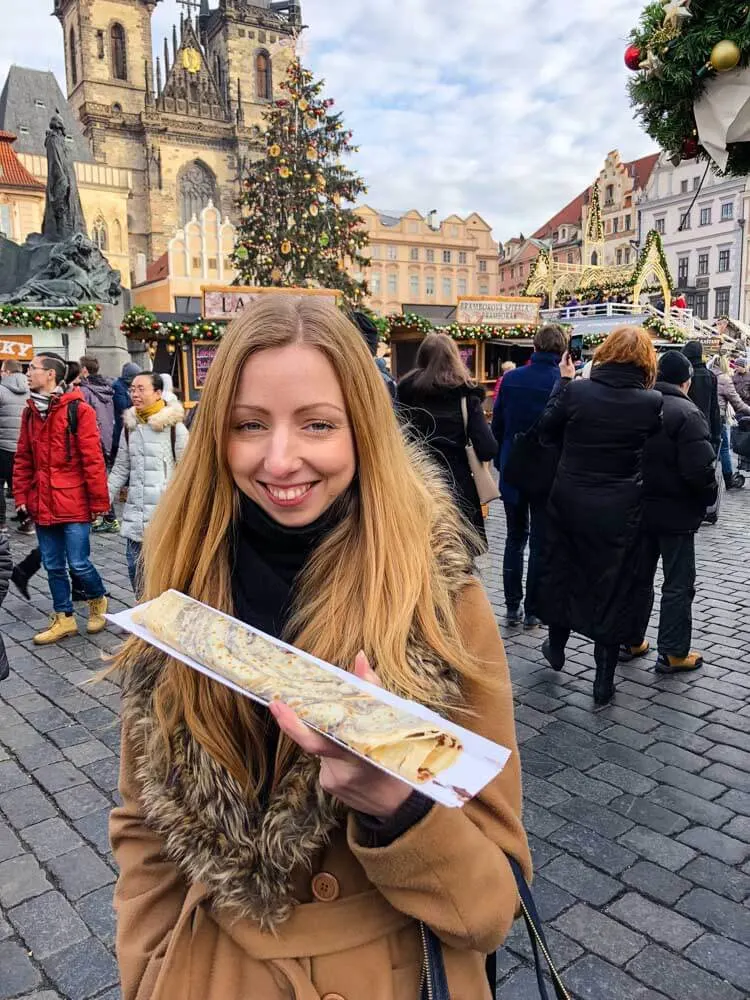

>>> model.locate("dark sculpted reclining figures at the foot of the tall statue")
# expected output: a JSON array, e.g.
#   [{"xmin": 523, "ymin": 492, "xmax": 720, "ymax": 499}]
[{"xmin": 0, "ymin": 233, "xmax": 121, "ymax": 306}]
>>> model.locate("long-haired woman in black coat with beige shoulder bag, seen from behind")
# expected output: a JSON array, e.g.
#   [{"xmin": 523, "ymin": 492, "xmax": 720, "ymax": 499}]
[{"xmin": 396, "ymin": 333, "xmax": 498, "ymax": 545}]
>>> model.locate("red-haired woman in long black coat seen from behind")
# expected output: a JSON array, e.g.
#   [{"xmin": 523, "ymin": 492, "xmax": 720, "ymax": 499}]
[{"xmin": 539, "ymin": 326, "xmax": 662, "ymax": 704}]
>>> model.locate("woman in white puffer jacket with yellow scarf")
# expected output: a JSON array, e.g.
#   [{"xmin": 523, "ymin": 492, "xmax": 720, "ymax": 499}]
[{"xmin": 109, "ymin": 372, "xmax": 188, "ymax": 598}]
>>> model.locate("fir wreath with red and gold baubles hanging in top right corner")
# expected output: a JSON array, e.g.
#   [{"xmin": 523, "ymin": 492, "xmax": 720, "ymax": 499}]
[{"xmin": 625, "ymin": 0, "xmax": 750, "ymax": 175}]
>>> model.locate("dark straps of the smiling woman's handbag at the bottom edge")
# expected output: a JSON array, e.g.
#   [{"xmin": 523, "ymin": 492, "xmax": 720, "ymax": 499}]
[{"xmin": 419, "ymin": 856, "xmax": 571, "ymax": 1000}]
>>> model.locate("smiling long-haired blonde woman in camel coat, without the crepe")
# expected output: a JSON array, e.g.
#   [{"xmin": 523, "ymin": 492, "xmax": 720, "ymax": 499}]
[{"xmin": 111, "ymin": 296, "xmax": 530, "ymax": 1000}]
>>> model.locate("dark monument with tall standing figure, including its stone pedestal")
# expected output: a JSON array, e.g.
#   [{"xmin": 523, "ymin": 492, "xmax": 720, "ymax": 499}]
[{"xmin": 0, "ymin": 112, "xmax": 130, "ymax": 375}]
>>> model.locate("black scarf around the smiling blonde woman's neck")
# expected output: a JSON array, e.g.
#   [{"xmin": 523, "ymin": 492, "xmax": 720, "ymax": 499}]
[{"xmin": 232, "ymin": 490, "xmax": 353, "ymax": 638}]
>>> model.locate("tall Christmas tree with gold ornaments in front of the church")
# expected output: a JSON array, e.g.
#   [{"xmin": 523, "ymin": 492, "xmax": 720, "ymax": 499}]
[{"xmin": 233, "ymin": 60, "xmax": 367, "ymax": 303}]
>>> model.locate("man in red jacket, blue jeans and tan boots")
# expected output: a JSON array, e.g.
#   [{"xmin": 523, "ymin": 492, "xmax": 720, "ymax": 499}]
[{"xmin": 13, "ymin": 354, "xmax": 109, "ymax": 645}]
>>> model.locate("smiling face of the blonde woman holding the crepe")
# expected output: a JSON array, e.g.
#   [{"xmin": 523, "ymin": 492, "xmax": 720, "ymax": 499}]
[{"xmin": 227, "ymin": 344, "xmax": 356, "ymax": 527}]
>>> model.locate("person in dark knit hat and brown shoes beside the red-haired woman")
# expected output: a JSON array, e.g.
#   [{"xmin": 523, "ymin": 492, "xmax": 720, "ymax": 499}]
[{"xmin": 632, "ymin": 350, "xmax": 717, "ymax": 674}]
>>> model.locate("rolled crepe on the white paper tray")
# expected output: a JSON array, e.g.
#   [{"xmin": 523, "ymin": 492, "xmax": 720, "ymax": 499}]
[{"xmin": 133, "ymin": 590, "xmax": 463, "ymax": 784}]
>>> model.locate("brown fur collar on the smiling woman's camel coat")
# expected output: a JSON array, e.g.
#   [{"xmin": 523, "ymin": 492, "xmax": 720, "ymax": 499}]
[{"xmin": 122, "ymin": 508, "xmax": 473, "ymax": 931}]
